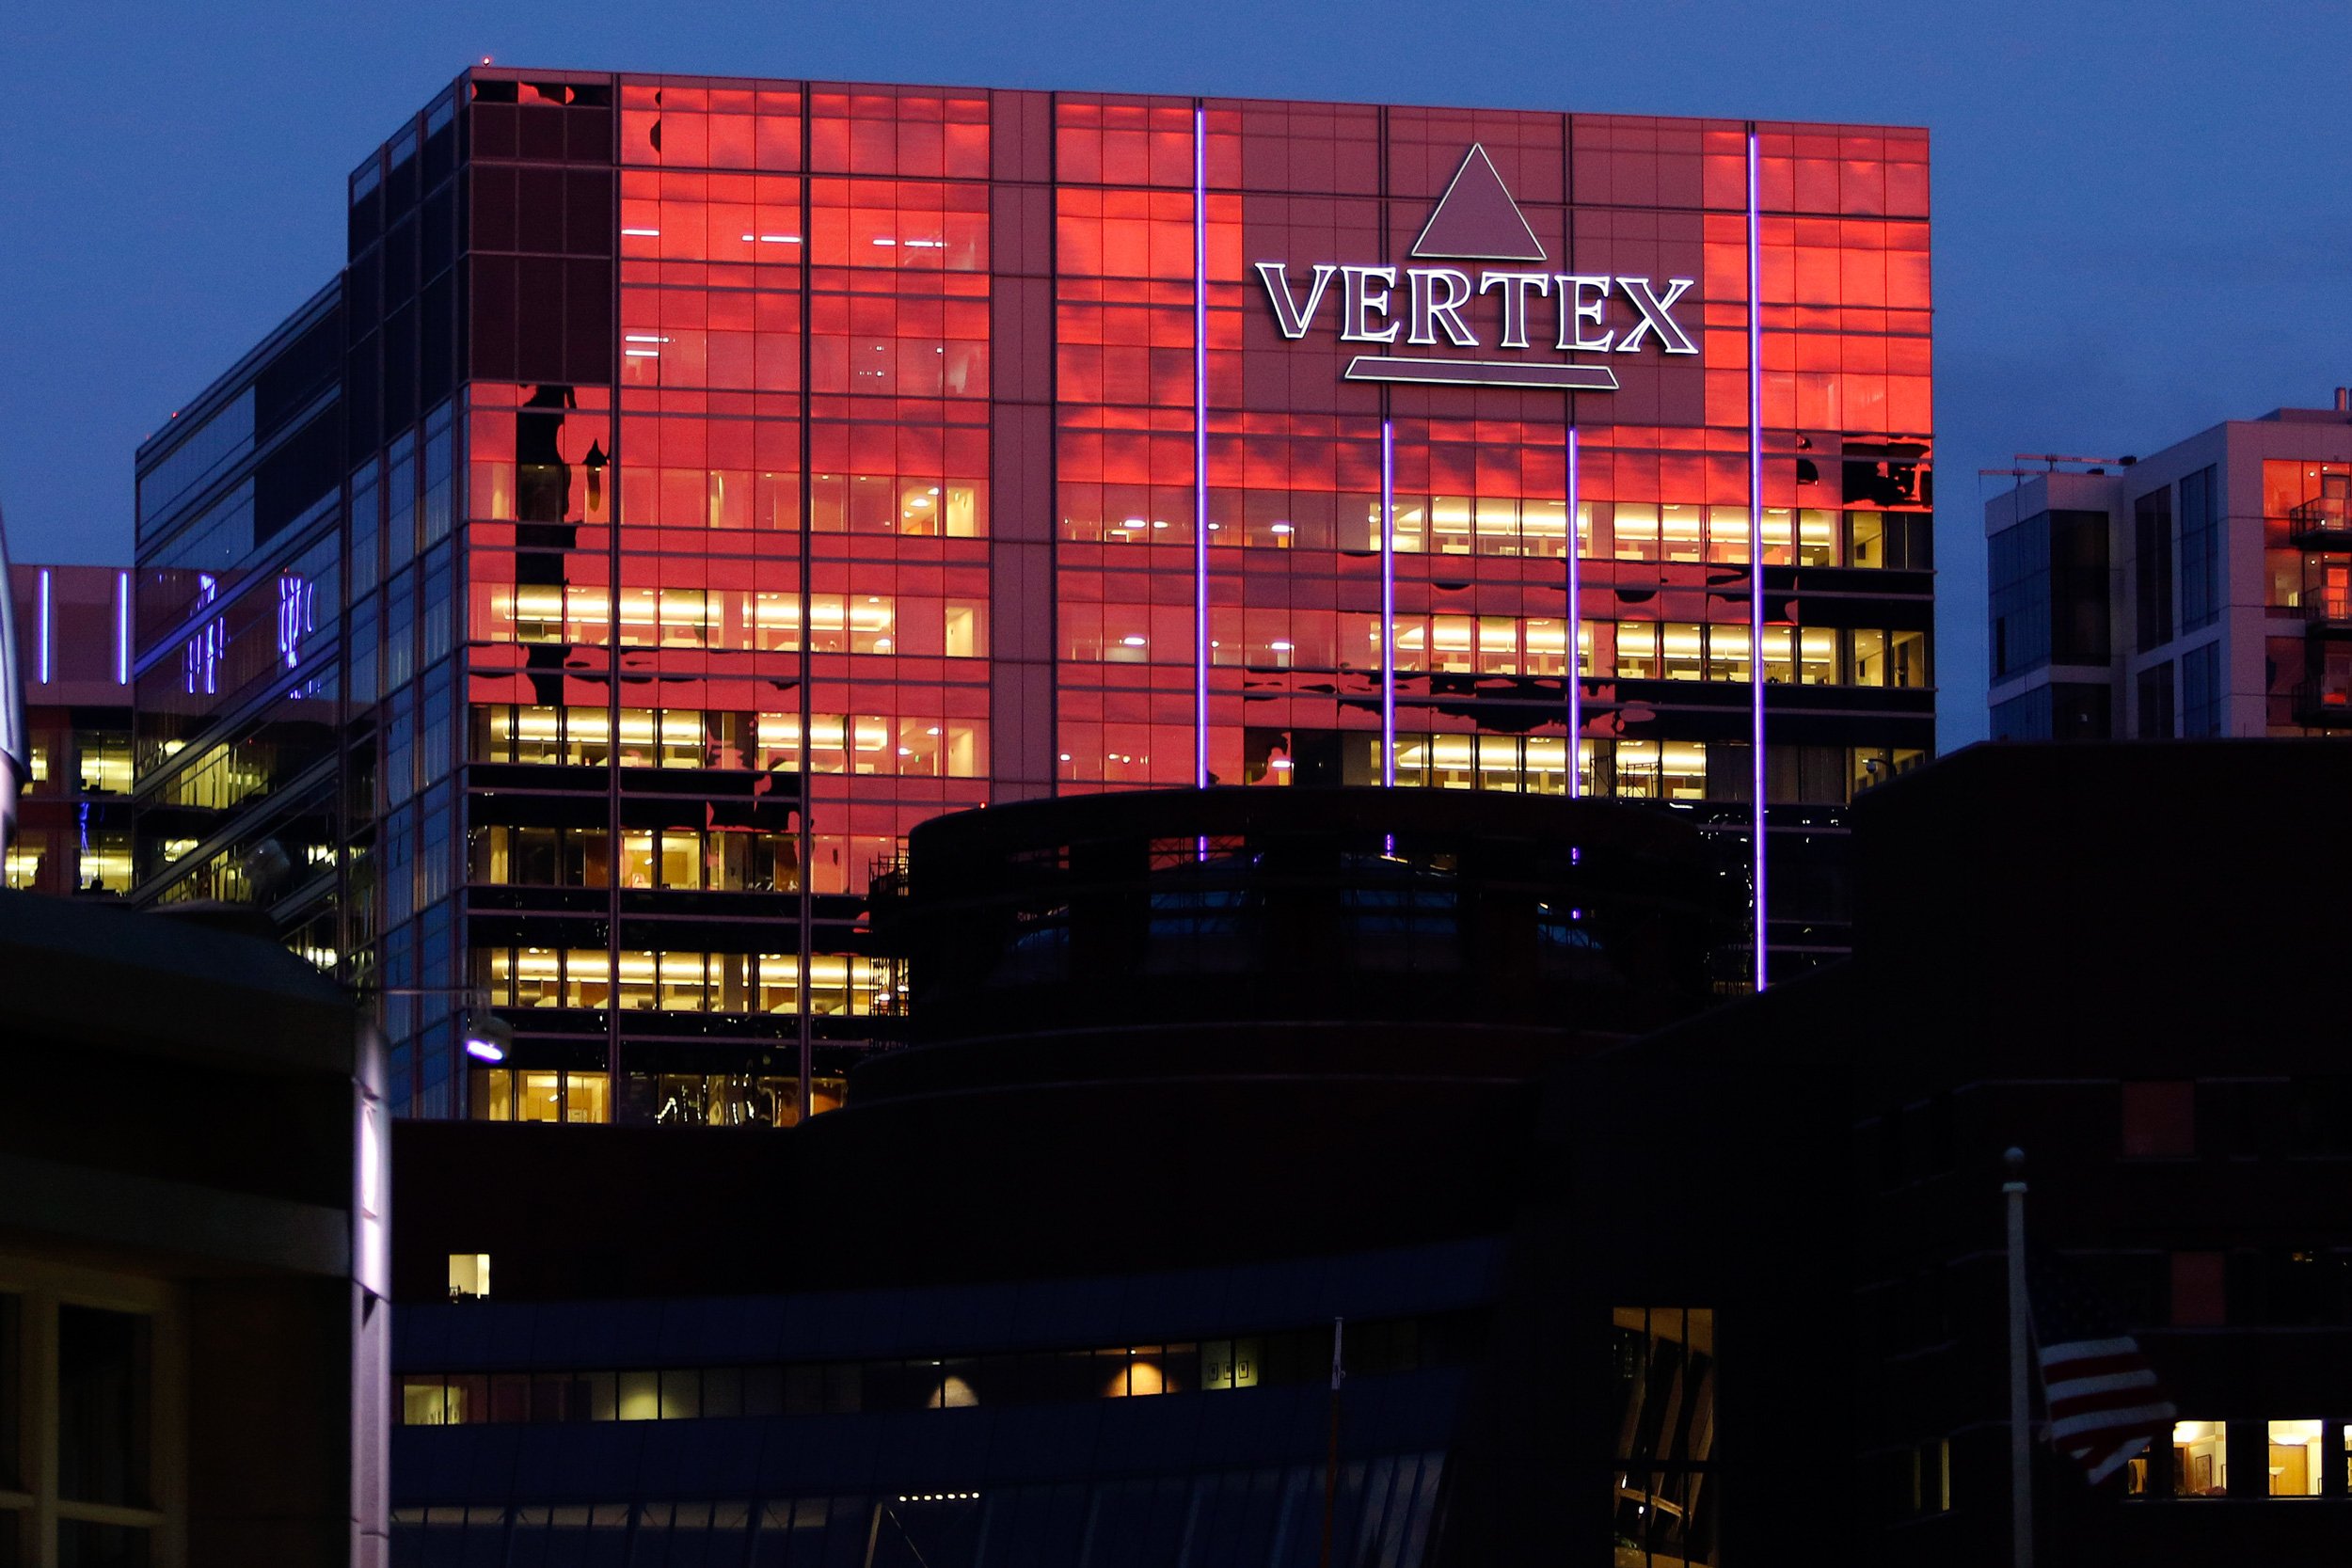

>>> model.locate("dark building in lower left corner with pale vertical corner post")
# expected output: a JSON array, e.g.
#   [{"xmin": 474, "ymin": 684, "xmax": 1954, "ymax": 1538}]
[{"xmin": 0, "ymin": 894, "xmax": 390, "ymax": 1568}]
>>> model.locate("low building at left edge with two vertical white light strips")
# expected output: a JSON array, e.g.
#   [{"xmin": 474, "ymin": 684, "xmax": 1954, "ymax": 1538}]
[{"xmin": 5, "ymin": 564, "xmax": 132, "ymax": 898}]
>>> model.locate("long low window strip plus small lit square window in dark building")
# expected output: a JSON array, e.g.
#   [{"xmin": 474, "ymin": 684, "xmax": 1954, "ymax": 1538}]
[{"xmin": 400, "ymin": 1316, "xmax": 1439, "ymax": 1427}]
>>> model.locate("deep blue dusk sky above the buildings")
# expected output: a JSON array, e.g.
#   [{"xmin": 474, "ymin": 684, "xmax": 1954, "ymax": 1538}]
[{"xmin": 0, "ymin": 0, "xmax": 2352, "ymax": 748}]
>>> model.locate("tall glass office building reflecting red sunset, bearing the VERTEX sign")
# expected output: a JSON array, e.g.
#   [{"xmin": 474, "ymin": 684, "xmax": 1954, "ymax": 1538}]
[{"xmin": 123, "ymin": 68, "xmax": 1933, "ymax": 1124}]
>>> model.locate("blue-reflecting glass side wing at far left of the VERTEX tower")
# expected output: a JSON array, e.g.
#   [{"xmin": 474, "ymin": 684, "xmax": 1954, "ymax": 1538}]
[{"xmin": 118, "ymin": 279, "xmax": 343, "ymax": 969}]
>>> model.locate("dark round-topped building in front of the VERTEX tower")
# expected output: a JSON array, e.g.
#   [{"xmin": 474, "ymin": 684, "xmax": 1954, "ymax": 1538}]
[{"xmin": 395, "ymin": 790, "xmax": 1739, "ymax": 1566}]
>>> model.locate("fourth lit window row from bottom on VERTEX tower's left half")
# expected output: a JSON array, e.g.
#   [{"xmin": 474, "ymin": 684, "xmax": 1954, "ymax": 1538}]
[{"xmin": 473, "ymin": 703, "xmax": 988, "ymax": 778}]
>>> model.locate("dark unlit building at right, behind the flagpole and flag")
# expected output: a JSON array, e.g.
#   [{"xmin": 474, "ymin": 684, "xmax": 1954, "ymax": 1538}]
[{"xmin": 1454, "ymin": 740, "xmax": 2352, "ymax": 1566}]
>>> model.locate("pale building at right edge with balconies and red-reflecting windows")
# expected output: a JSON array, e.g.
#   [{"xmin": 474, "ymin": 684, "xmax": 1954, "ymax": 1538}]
[{"xmin": 1985, "ymin": 392, "xmax": 2352, "ymax": 740}]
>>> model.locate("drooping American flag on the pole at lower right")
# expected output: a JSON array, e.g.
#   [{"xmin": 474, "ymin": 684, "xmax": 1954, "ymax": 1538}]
[{"xmin": 2027, "ymin": 1258, "xmax": 2176, "ymax": 1486}]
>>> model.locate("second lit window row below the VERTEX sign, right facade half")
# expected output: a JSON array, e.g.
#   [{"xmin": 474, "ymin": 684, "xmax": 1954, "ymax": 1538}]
[{"xmin": 1061, "ymin": 604, "xmax": 1933, "ymax": 689}]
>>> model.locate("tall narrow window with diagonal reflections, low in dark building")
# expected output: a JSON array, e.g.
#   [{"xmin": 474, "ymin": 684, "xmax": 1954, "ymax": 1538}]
[{"xmin": 1612, "ymin": 1307, "xmax": 1720, "ymax": 1568}]
